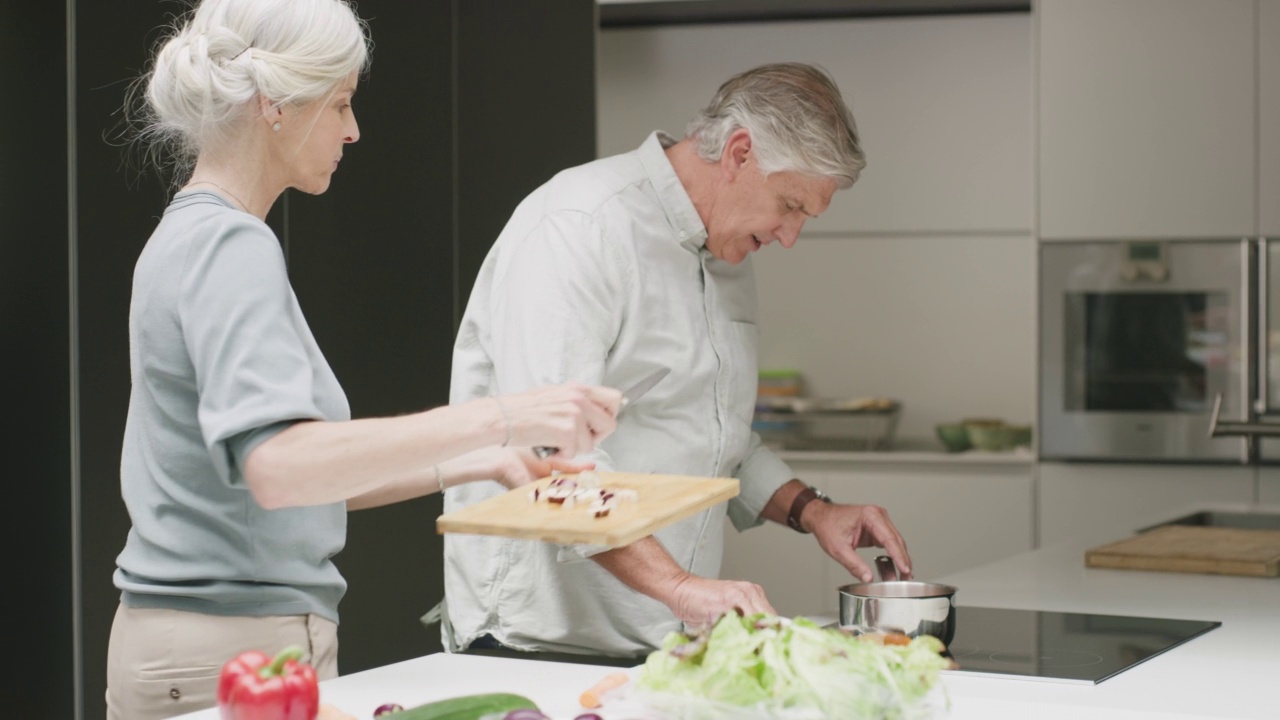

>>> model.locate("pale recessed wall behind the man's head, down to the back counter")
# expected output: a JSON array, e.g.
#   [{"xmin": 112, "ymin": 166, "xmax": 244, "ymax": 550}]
[{"xmin": 598, "ymin": 14, "xmax": 1036, "ymax": 437}]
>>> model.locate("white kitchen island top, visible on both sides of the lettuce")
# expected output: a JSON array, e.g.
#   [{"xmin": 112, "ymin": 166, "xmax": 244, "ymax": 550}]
[{"xmin": 172, "ymin": 527, "xmax": 1280, "ymax": 720}]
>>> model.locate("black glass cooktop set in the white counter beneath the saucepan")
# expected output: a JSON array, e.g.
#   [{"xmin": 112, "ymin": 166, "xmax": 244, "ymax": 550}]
[{"xmin": 948, "ymin": 606, "xmax": 1221, "ymax": 683}]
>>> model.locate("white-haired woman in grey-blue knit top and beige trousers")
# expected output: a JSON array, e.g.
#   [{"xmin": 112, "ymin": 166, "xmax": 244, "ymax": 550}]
[{"xmin": 106, "ymin": 0, "xmax": 620, "ymax": 720}]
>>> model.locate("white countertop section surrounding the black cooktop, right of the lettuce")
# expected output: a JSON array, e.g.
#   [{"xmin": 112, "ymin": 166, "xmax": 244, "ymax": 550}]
[{"xmin": 921, "ymin": 538, "xmax": 1280, "ymax": 720}]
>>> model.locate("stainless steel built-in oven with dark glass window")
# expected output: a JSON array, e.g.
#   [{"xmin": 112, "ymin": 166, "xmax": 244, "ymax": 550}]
[{"xmin": 1039, "ymin": 241, "xmax": 1252, "ymax": 462}]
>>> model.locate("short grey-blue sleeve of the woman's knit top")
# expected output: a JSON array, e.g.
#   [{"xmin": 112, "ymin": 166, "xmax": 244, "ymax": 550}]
[{"xmin": 178, "ymin": 218, "xmax": 335, "ymax": 484}]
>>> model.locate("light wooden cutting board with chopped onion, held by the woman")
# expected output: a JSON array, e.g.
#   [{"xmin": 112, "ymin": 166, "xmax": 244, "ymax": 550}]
[{"xmin": 435, "ymin": 471, "xmax": 739, "ymax": 547}]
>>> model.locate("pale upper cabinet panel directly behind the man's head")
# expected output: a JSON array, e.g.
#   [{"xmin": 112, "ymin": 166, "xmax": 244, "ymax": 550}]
[{"xmin": 596, "ymin": 13, "xmax": 1034, "ymax": 237}]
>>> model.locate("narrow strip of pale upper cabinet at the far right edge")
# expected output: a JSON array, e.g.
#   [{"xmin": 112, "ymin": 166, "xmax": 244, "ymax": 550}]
[{"xmin": 1258, "ymin": 0, "xmax": 1280, "ymax": 238}]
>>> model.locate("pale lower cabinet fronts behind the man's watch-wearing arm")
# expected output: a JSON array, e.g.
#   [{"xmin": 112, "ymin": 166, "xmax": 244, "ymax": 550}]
[{"xmin": 721, "ymin": 461, "xmax": 1033, "ymax": 615}]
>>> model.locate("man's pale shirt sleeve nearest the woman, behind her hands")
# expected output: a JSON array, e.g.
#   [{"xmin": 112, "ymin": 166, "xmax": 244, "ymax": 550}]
[{"xmin": 489, "ymin": 211, "xmax": 627, "ymax": 562}]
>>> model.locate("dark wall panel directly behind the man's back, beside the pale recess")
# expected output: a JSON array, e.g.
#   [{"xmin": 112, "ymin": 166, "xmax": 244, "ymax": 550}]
[{"xmin": 458, "ymin": 0, "xmax": 595, "ymax": 316}]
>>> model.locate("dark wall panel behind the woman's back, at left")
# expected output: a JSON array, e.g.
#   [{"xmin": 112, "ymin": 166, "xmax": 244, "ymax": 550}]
[{"xmin": 74, "ymin": 0, "xmax": 179, "ymax": 719}]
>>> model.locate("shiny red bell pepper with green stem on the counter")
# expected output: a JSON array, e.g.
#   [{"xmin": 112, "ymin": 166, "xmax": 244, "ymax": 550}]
[{"xmin": 218, "ymin": 647, "xmax": 320, "ymax": 720}]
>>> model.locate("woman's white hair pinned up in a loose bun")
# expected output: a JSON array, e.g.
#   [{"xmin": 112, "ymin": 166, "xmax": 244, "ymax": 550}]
[{"xmin": 125, "ymin": 0, "xmax": 371, "ymax": 179}]
